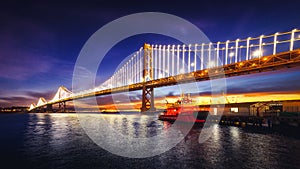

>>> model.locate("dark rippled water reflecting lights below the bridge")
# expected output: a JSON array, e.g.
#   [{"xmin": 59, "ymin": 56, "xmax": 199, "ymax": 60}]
[{"xmin": 0, "ymin": 114, "xmax": 300, "ymax": 169}]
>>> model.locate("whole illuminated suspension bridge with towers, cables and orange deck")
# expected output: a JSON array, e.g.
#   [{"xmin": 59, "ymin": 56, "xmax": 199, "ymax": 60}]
[{"xmin": 29, "ymin": 29, "xmax": 300, "ymax": 112}]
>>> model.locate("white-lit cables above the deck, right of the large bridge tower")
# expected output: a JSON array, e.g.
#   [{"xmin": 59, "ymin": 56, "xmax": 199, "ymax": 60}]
[{"xmin": 152, "ymin": 29, "xmax": 300, "ymax": 79}]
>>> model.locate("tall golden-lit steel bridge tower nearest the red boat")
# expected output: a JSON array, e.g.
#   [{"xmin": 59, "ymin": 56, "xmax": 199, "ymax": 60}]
[{"xmin": 141, "ymin": 43, "xmax": 156, "ymax": 112}]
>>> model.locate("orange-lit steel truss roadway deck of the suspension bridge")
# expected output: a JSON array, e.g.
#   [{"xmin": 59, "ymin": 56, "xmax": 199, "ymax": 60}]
[{"xmin": 47, "ymin": 49, "xmax": 300, "ymax": 104}]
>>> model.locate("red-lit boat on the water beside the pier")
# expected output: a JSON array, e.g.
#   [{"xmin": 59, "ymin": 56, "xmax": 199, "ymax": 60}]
[{"xmin": 158, "ymin": 94, "xmax": 209, "ymax": 123}]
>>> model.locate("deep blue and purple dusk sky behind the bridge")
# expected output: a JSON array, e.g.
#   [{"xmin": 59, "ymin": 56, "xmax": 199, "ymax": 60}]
[{"xmin": 0, "ymin": 0, "xmax": 300, "ymax": 107}]
